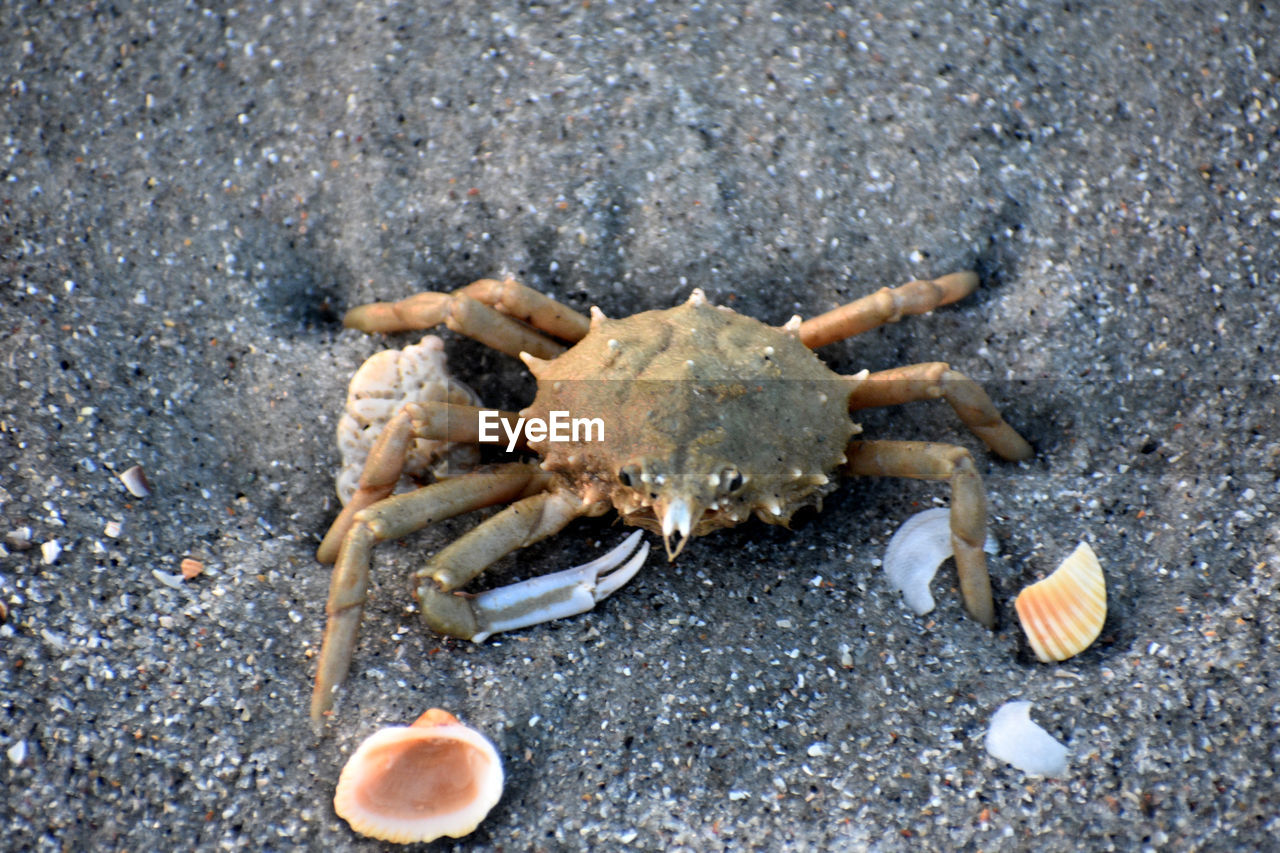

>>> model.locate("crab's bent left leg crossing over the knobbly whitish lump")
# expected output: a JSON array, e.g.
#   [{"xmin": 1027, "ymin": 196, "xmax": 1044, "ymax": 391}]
[{"xmin": 316, "ymin": 402, "xmax": 524, "ymax": 562}]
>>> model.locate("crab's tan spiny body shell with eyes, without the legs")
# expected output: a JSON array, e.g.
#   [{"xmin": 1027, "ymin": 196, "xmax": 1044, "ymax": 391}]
[{"xmin": 521, "ymin": 291, "xmax": 865, "ymax": 556}]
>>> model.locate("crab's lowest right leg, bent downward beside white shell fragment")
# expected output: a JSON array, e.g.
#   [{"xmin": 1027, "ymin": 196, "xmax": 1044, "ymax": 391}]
[{"xmin": 842, "ymin": 441, "xmax": 996, "ymax": 628}]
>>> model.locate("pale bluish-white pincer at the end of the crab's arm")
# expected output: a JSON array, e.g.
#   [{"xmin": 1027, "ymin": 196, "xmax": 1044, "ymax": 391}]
[{"xmin": 471, "ymin": 530, "xmax": 649, "ymax": 643}]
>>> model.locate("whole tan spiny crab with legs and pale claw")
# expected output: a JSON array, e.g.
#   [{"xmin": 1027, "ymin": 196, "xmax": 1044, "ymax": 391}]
[{"xmin": 311, "ymin": 272, "xmax": 1032, "ymax": 722}]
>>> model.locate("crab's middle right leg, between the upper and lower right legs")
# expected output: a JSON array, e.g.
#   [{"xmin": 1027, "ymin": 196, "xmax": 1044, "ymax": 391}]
[{"xmin": 849, "ymin": 361, "xmax": 1033, "ymax": 460}]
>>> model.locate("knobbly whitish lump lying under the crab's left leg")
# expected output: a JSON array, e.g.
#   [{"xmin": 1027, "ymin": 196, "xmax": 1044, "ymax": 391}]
[{"xmin": 338, "ymin": 334, "xmax": 480, "ymax": 505}]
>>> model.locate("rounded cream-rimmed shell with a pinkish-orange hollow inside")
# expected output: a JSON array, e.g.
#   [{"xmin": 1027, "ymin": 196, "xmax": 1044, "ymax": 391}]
[{"xmin": 333, "ymin": 708, "xmax": 503, "ymax": 844}]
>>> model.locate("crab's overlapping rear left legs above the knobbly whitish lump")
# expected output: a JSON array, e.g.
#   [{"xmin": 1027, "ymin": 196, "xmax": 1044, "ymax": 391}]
[{"xmin": 343, "ymin": 278, "xmax": 590, "ymax": 359}]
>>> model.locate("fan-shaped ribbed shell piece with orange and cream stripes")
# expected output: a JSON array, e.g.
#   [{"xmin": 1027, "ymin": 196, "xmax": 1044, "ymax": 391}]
[{"xmin": 1014, "ymin": 542, "xmax": 1107, "ymax": 663}]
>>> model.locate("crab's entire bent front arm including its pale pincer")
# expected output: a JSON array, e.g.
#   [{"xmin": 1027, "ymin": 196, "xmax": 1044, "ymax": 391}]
[{"xmin": 410, "ymin": 492, "xmax": 637, "ymax": 643}]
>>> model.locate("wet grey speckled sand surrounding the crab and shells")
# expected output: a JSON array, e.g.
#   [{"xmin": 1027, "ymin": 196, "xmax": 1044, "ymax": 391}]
[{"xmin": 0, "ymin": 0, "xmax": 1280, "ymax": 852}]
